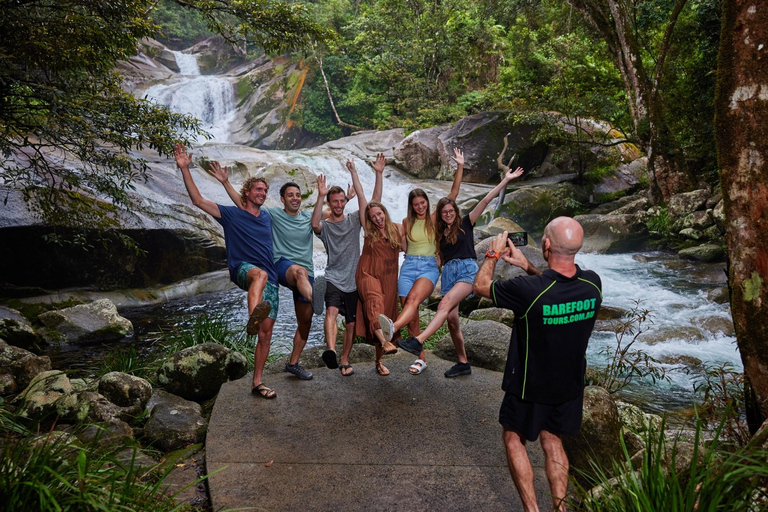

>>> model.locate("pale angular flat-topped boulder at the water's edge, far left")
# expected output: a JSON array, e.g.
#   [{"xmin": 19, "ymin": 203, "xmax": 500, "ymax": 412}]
[{"xmin": 38, "ymin": 299, "xmax": 133, "ymax": 343}]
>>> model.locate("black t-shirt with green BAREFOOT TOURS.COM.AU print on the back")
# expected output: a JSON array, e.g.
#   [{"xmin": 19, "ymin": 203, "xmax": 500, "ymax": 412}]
[{"xmin": 491, "ymin": 266, "xmax": 603, "ymax": 404}]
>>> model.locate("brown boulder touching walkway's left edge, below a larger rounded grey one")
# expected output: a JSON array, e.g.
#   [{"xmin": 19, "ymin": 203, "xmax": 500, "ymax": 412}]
[{"xmin": 144, "ymin": 390, "xmax": 208, "ymax": 452}]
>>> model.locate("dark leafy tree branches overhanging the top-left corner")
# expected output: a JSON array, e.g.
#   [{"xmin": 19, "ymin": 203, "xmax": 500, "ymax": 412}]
[{"xmin": 0, "ymin": 0, "xmax": 326, "ymax": 231}]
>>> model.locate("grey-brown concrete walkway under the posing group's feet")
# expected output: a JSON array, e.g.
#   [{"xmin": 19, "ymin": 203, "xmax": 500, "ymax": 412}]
[{"xmin": 206, "ymin": 351, "xmax": 552, "ymax": 511}]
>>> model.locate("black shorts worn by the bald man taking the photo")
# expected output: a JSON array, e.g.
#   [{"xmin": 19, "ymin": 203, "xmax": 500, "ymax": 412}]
[{"xmin": 499, "ymin": 393, "xmax": 584, "ymax": 441}]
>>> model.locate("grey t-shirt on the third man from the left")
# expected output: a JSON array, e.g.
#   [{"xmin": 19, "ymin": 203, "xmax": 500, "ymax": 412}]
[{"xmin": 317, "ymin": 212, "xmax": 362, "ymax": 292}]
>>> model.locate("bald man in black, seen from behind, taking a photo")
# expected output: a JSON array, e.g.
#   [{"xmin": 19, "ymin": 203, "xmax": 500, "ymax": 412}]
[{"xmin": 474, "ymin": 217, "xmax": 602, "ymax": 511}]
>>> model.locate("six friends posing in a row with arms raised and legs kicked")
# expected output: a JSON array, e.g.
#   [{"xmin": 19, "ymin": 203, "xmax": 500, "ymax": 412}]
[{"xmin": 174, "ymin": 145, "xmax": 523, "ymax": 398}]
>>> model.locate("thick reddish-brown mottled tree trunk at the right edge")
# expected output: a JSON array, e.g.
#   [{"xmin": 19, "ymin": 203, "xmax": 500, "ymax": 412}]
[{"xmin": 715, "ymin": 0, "xmax": 768, "ymax": 421}]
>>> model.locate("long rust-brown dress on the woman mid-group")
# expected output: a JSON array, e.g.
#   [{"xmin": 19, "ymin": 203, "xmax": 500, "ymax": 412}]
[{"xmin": 355, "ymin": 237, "xmax": 400, "ymax": 344}]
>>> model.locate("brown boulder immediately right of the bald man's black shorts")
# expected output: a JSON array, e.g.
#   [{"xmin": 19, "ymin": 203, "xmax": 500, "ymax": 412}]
[{"xmin": 563, "ymin": 386, "xmax": 623, "ymax": 478}]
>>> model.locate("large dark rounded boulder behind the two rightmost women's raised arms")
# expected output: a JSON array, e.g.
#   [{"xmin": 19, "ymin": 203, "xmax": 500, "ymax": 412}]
[{"xmin": 438, "ymin": 111, "xmax": 549, "ymax": 184}]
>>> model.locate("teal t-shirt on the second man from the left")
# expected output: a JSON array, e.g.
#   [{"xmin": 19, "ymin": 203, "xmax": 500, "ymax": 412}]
[{"xmin": 262, "ymin": 206, "xmax": 315, "ymax": 277}]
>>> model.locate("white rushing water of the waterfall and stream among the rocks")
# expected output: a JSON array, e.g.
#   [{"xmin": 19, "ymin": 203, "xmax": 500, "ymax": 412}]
[{"xmin": 46, "ymin": 48, "xmax": 741, "ymax": 420}]
